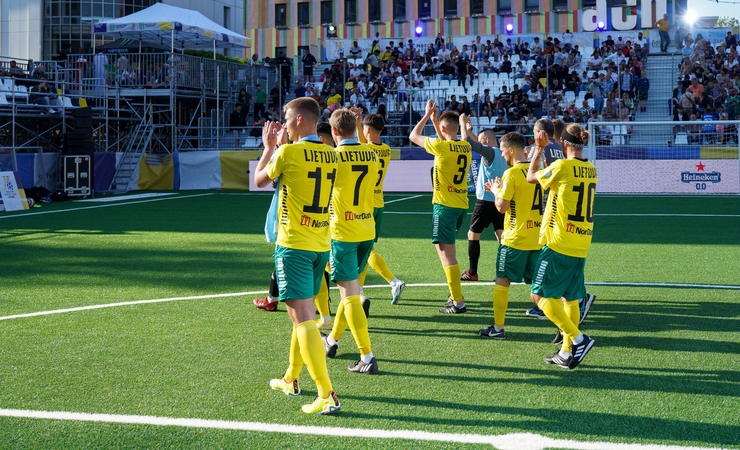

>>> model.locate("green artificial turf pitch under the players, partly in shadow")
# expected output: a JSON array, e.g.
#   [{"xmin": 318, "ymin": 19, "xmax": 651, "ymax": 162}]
[{"xmin": 0, "ymin": 192, "xmax": 740, "ymax": 448}]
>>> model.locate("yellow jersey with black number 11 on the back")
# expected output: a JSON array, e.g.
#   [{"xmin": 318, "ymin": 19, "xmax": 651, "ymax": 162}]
[{"xmin": 266, "ymin": 141, "xmax": 337, "ymax": 252}]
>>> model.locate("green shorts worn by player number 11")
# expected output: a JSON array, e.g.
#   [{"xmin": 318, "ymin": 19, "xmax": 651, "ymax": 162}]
[{"xmin": 275, "ymin": 245, "xmax": 329, "ymax": 302}]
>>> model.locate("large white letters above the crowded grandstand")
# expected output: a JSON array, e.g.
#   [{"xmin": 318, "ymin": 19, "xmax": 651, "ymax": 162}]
[{"xmin": 581, "ymin": 0, "xmax": 668, "ymax": 31}]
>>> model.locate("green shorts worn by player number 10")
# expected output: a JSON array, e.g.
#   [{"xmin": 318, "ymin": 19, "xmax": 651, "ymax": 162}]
[{"xmin": 532, "ymin": 246, "xmax": 586, "ymax": 300}]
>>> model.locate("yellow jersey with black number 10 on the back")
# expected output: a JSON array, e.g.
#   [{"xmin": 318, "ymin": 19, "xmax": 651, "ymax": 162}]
[{"xmin": 537, "ymin": 159, "xmax": 598, "ymax": 258}]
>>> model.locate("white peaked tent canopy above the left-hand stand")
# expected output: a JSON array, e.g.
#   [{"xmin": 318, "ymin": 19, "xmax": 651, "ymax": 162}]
[{"xmin": 95, "ymin": 3, "xmax": 251, "ymax": 49}]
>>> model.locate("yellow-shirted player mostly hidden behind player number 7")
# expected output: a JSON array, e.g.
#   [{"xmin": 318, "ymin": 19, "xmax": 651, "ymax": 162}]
[{"xmin": 351, "ymin": 107, "xmax": 406, "ymax": 308}]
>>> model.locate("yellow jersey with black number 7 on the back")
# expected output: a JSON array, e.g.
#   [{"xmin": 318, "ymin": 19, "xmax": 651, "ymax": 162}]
[{"xmin": 331, "ymin": 143, "xmax": 379, "ymax": 242}]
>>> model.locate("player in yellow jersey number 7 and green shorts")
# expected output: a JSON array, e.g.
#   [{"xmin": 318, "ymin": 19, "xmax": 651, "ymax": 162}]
[{"xmin": 323, "ymin": 108, "xmax": 379, "ymax": 374}]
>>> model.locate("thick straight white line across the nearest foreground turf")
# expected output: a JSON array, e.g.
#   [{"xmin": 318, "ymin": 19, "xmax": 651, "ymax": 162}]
[{"xmin": 0, "ymin": 409, "xmax": 716, "ymax": 450}]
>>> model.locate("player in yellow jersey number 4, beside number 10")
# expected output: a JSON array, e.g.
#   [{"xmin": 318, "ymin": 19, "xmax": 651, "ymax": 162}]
[{"xmin": 480, "ymin": 132, "xmax": 542, "ymax": 339}]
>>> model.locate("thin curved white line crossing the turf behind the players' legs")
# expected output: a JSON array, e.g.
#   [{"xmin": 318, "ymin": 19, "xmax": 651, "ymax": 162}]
[{"xmin": 0, "ymin": 281, "xmax": 740, "ymax": 321}]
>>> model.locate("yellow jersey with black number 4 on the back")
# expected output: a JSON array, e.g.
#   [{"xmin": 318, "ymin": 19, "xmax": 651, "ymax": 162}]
[{"xmin": 496, "ymin": 162, "xmax": 542, "ymax": 250}]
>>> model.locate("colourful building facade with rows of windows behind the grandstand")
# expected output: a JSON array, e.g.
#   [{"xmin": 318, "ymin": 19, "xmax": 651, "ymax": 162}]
[{"xmin": 244, "ymin": 0, "xmax": 686, "ymax": 57}]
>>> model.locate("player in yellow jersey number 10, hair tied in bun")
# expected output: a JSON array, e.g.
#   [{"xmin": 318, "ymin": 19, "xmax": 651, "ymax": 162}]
[{"xmin": 527, "ymin": 124, "xmax": 598, "ymax": 369}]
